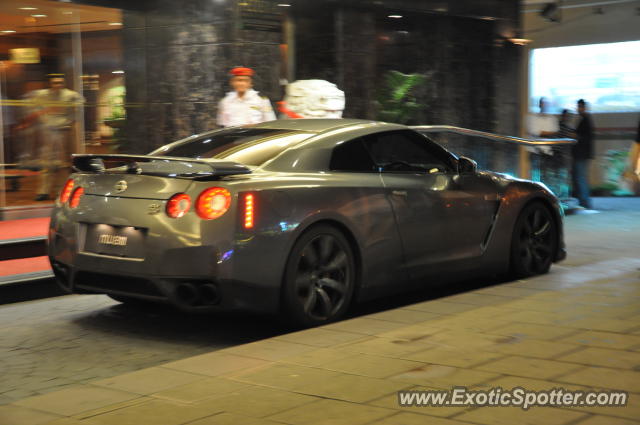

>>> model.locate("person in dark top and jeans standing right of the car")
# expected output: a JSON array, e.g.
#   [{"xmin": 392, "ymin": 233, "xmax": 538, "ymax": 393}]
[{"xmin": 571, "ymin": 99, "xmax": 594, "ymax": 210}]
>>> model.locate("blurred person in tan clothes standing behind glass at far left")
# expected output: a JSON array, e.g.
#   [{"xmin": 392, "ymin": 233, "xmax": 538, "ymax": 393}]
[{"xmin": 23, "ymin": 74, "xmax": 84, "ymax": 201}]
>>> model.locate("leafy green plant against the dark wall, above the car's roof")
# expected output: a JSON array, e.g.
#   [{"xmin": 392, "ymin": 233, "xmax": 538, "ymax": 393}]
[{"xmin": 376, "ymin": 71, "xmax": 427, "ymax": 124}]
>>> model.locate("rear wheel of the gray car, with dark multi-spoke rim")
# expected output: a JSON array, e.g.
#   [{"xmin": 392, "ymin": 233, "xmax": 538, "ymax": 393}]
[{"xmin": 282, "ymin": 224, "xmax": 356, "ymax": 327}]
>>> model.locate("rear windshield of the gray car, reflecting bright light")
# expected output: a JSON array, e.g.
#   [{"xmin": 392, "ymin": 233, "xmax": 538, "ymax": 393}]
[{"xmin": 151, "ymin": 128, "xmax": 313, "ymax": 166}]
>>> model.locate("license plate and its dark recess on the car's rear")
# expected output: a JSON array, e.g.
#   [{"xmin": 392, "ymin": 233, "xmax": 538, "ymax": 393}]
[{"xmin": 83, "ymin": 224, "xmax": 146, "ymax": 258}]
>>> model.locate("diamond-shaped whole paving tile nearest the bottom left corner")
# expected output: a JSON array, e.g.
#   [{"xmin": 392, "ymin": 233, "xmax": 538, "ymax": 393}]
[{"xmin": 15, "ymin": 385, "xmax": 140, "ymax": 416}]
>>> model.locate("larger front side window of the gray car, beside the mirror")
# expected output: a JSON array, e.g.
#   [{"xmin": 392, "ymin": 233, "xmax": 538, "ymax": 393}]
[{"xmin": 364, "ymin": 130, "xmax": 453, "ymax": 174}]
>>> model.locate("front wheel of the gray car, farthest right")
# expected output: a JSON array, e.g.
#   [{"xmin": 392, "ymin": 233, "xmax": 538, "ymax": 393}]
[{"xmin": 510, "ymin": 202, "xmax": 558, "ymax": 278}]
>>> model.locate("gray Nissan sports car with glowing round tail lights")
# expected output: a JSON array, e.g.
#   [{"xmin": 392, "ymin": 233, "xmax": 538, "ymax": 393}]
[{"xmin": 49, "ymin": 119, "xmax": 565, "ymax": 326}]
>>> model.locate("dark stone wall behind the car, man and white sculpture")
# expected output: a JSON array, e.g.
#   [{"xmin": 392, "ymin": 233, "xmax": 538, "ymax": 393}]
[{"xmin": 81, "ymin": 0, "xmax": 520, "ymax": 153}]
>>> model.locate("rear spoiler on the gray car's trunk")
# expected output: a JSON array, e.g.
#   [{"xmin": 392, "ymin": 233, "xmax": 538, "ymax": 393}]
[{"xmin": 72, "ymin": 154, "xmax": 251, "ymax": 178}]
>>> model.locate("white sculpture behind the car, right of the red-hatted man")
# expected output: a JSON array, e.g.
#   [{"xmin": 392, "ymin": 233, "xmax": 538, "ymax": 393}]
[{"xmin": 278, "ymin": 80, "xmax": 344, "ymax": 118}]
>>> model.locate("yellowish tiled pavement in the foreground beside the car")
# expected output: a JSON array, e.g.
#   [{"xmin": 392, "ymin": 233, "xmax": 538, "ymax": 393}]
[{"xmin": 0, "ymin": 253, "xmax": 640, "ymax": 425}]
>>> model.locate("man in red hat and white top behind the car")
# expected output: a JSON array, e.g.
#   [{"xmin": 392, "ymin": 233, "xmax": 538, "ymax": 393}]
[{"xmin": 218, "ymin": 67, "xmax": 276, "ymax": 127}]
